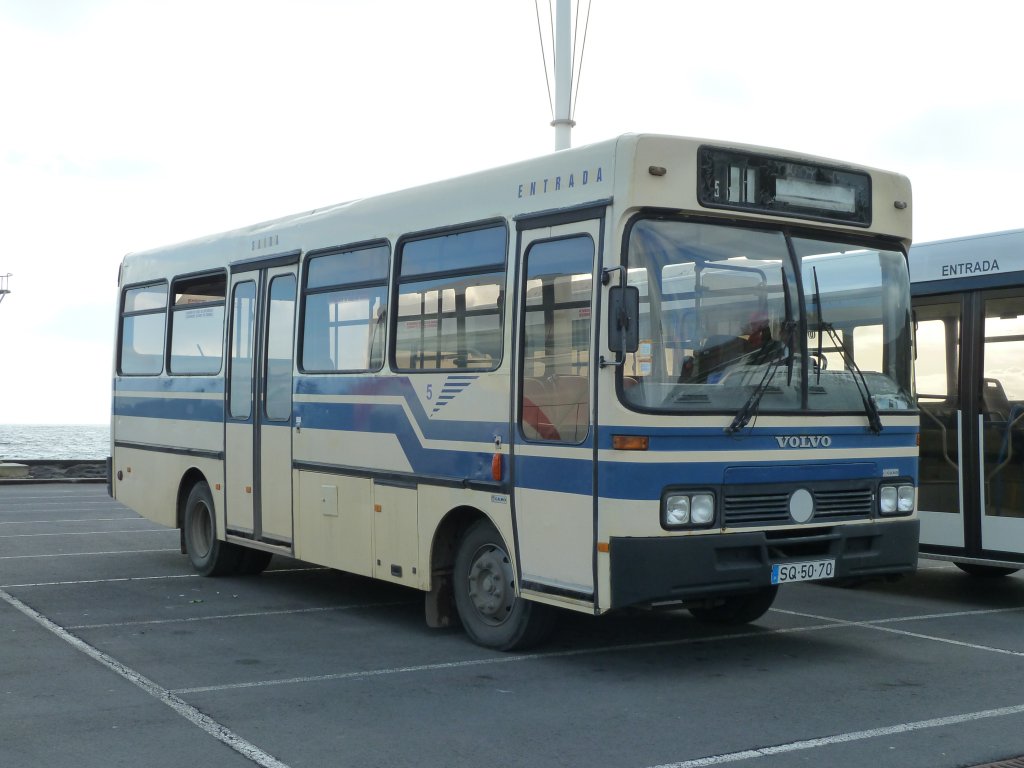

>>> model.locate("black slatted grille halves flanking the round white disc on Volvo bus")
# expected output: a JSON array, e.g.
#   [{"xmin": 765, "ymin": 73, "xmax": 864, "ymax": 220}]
[{"xmin": 722, "ymin": 481, "xmax": 874, "ymax": 527}]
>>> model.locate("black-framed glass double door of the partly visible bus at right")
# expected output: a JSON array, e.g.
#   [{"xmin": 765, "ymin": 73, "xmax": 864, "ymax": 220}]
[{"xmin": 914, "ymin": 289, "xmax": 1024, "ymax": 561}]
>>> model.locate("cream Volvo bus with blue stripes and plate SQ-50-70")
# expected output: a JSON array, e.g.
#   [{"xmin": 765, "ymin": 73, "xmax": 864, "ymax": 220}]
[{"xmin": 112, "ymin": 135, "xmax": 919, "ymax": 649}]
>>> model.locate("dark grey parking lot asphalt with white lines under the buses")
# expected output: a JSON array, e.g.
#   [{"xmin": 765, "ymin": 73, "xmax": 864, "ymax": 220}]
[{"xmin": 6, "ymin": 483, "xmax": 1024, "ymax": 768}]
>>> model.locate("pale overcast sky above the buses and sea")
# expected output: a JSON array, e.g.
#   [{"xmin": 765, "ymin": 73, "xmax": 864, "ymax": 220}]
[{"xmin": 0, "ymin": 0, "xmax": 1024, "ymax": 424}]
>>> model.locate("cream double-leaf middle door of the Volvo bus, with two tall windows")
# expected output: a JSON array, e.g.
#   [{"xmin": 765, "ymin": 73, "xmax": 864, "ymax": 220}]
[{"xmin": 224, "ymin": 256, "xmax": 298, "ymax": 550}]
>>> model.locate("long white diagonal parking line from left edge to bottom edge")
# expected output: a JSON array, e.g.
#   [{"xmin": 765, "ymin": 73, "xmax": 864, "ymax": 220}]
[{"xmin": 0, "ymin": 590, "xmax": 288, "ymax": 768}]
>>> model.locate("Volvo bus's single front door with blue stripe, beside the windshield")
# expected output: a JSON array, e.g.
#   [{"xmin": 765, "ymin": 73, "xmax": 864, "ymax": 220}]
[{"xmin": 512, "ymin": 218, "xmax": 602, "ymax": 602}]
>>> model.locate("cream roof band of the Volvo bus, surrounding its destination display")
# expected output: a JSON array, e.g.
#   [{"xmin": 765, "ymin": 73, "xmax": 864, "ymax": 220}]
[{"xmin": 121, "ymin": 134, "xmax": 910, "ymax": 285}]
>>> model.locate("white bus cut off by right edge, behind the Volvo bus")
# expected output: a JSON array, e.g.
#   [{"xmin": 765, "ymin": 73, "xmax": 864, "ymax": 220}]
[{"xmin": 910, "ymin": 230, "xmax": 1024, "ymax": 577}]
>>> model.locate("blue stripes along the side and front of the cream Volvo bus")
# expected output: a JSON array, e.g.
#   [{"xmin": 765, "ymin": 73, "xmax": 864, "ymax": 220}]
[{"xmin": 114, "ymin": 377, "xmax": 916, "ymax": 500}]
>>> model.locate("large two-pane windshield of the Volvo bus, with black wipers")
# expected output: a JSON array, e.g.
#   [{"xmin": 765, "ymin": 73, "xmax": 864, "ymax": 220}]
[{"xmin": 623, "ymin": 218, "xmax": 913, "ymax": 421}]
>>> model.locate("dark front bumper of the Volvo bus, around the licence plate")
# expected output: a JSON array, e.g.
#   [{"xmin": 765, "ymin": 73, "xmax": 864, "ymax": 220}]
[{"xmin": 608, "ymin": 519, "xmax": 921, "ymax": 608}]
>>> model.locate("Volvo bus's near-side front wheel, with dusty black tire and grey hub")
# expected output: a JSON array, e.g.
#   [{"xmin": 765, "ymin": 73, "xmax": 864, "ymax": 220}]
[{"xmin": 453, "ymin": 520, "xmax": 555, "ymax": 650}]
